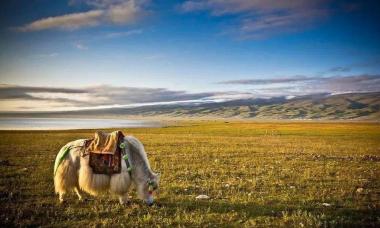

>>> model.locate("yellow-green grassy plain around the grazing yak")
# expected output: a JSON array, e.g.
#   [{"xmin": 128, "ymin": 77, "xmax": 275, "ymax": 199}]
[{"xmin": 0, "ymin": 121, "xmax": 380, "ymax": 227}]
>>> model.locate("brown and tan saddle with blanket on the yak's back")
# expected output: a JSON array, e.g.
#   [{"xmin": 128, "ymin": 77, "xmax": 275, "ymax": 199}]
[{"xmin": 85, "ymin": 131, "xmax": 124, "ymax": 175}]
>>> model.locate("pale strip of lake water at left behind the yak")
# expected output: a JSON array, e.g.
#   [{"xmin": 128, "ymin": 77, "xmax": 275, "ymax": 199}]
[{"xmin": 0, "ymin": 118, "xmax": 159, "ymax": 130}]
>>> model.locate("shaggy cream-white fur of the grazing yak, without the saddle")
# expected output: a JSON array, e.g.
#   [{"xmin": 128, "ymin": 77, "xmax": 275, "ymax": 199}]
[{"xmin": 54, "ymin": 136, "xmax": 159, "ymax": 204}]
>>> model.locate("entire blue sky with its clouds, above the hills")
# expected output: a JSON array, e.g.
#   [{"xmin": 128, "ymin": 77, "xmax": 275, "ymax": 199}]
[{"xmin": 0, "ymin": 0, "xmax": 380, "ymax": 111}]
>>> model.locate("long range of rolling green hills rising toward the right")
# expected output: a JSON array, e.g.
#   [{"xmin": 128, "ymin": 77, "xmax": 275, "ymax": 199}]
[{"xmin": 1, "ymin": 92, "xmax": 380, "ymax": 120}]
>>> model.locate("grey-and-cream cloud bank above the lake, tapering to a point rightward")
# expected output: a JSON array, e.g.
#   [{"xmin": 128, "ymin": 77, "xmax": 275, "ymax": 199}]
[{"xmin": 0, "ymin": 85, "xmax": 219, "ymax": 111}]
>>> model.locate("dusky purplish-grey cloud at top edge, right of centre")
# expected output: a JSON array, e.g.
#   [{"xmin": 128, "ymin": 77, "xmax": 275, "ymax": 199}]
[{"xmin": 180, "ymin": 0, "xmax": 329, "ymax": 38}]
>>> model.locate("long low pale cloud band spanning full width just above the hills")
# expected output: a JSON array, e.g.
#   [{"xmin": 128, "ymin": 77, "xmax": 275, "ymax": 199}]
[{"xmin": 0, "ymin": 75, "xmax": 380, "ymax": 112}]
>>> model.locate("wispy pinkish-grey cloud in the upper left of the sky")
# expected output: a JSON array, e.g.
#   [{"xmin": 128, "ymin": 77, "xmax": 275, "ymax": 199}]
[{"xmin": 17, "ymin": 0, "xmax": 148, "ymax": 32}]
